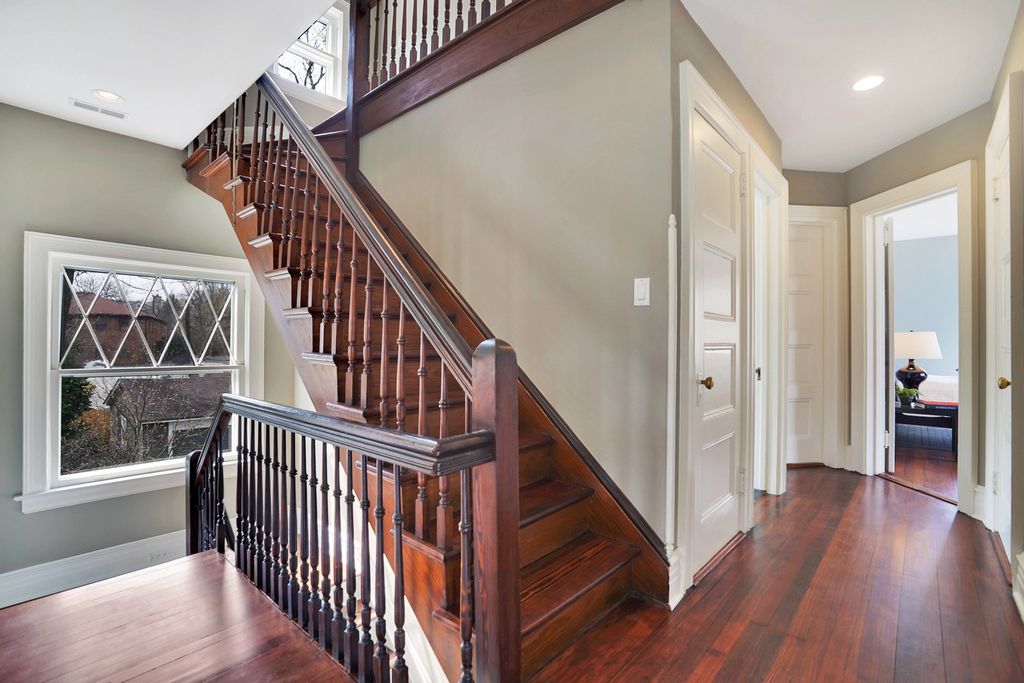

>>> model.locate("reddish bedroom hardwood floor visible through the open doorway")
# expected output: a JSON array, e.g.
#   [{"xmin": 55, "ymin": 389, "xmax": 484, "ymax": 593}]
[{"xmin": 893, "ymin": 425, "xmax": 957, "ymax": 501}]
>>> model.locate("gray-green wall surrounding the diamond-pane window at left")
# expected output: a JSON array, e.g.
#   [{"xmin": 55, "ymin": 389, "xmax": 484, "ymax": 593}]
[{"xmin": 0, "ymin": 104, "xmax": 294, "ymax": 572}]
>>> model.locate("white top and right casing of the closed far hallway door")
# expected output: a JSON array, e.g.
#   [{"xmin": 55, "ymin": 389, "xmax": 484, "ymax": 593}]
[{"xmin": 783, "ymin": 205, "xmax": 850, "ymax": 468}]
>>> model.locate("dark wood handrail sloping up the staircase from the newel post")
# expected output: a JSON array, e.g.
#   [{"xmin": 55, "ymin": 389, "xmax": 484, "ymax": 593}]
[{"xmin": 257, "ymin": 74, "xmax": 473, "ymax": 396}]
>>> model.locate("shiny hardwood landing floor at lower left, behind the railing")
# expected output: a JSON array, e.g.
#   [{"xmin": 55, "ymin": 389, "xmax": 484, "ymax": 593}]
[{"xmin": 0, "ymin": 551, "xmax": 352, "ymax": 683}]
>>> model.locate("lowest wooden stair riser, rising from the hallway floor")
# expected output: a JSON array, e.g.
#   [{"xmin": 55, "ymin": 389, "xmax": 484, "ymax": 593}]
[{"xmin": 522, "ymin": 564, "xmax": 631, "ymax": 680}]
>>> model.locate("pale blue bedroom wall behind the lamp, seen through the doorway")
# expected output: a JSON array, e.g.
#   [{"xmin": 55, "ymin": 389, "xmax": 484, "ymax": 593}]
[{"xmin": 893, "ymin": 236, "xmax": 959, "ymax": 375}]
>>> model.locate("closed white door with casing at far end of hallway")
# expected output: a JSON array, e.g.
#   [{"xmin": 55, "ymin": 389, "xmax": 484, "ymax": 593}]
[{"xmin": 785, "ymin": 206, "xmax": 847, "ymax": 467}]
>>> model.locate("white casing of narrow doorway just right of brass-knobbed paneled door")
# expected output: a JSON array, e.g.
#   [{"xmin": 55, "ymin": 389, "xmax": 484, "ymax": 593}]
[{"xmin": 746, "ymin": 148, "xmax": 790, "ymax": 497}]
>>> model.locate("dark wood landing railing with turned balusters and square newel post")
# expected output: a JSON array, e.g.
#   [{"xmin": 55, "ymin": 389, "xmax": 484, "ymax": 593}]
[{"xmin": 186, "ymin": 348, "xmax": 521, "ymax": 683}]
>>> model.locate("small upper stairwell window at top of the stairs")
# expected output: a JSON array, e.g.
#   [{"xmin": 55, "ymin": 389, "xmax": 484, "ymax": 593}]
[{"xmin": 270, "ymin": 3, "xmax": 346, "ymax": 103}]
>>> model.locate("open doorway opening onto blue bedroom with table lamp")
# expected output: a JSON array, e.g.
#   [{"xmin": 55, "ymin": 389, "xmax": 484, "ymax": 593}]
[{"xmin": 881, "ymin": 189, "xmax": 959, "ymax": 505}]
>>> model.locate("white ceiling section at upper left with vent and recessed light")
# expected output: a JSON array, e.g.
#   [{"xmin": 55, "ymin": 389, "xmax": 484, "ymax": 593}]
[{"xmin": 0, "ymin": 0, "xmax": 332, "ymax": 148}]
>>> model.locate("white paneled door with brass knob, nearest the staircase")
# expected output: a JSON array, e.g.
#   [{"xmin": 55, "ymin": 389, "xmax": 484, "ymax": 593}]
[{"xmin": 691, "ymin": 114, "xmax": 743, "ymax": 570}]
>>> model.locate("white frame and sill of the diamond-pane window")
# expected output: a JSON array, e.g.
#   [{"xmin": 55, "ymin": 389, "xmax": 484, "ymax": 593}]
[{"xmin": 14, "ymin": 231, "xmax": 265, "ymax": 513}]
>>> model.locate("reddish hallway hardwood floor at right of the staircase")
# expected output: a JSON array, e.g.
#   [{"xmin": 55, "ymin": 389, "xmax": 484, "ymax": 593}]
[{"xmin": 535, "ymin": 468, "xmax": 1024, "ymax": 683}]
